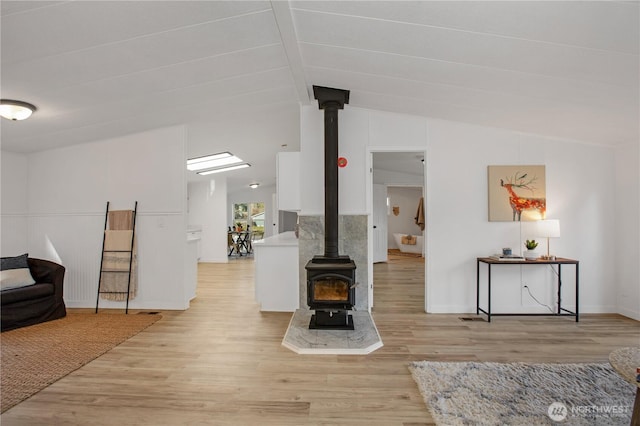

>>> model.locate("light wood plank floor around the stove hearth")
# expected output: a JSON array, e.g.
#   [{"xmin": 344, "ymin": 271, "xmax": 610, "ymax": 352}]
[{"xmin": 1, "ymin": 257, "xmax": 640, "ymax": 426}]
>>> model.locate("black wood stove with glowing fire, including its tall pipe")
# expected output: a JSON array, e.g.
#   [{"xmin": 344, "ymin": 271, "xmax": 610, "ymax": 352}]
[{"xmin": 305, "ymin": 86, "xmax": 356, "ymax": 330}]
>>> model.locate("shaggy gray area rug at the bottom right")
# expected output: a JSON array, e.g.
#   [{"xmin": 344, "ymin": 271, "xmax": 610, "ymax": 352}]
[{"xmin": 409, "ymin": 361, "xmax": 636, "ymax": 426}]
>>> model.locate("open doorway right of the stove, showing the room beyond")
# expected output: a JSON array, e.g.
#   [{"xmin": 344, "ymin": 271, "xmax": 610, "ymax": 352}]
[{"xmin": 368, "ymin": 148, "xmax": 428, "ymax": 312}]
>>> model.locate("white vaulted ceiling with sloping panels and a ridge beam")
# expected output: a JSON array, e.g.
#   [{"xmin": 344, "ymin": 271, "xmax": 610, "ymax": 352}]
[{"xmin": 0, "ymin": 0, "xmax": 640, "ymax": 190}]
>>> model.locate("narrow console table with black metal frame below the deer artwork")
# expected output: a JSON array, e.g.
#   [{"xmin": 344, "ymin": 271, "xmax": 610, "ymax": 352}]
[{"xmin": 476, "ymin": 257, "xmax": 580, "ymax": 322}]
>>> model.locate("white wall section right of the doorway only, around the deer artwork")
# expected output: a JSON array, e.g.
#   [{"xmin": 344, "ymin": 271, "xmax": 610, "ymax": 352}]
[{"xmin": 427, "ymin": 120, "xmax": 616, "ymax": 312}]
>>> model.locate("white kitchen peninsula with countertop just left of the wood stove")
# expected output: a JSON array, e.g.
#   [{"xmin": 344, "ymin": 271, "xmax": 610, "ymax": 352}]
[{"xmin": 253, "ymin": 232, "xmax": 300, "ymax": 312}]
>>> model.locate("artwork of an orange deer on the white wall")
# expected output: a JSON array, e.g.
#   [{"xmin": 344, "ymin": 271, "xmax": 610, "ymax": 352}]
[{"xmin": 487, "ymin": 166, "xmax": 547, "ymax": 222}]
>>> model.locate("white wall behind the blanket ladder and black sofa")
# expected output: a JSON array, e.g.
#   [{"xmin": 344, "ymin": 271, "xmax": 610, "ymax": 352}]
[{"xmin": 28, "ymin": 127, "xmax": 188, "ymax": 309}]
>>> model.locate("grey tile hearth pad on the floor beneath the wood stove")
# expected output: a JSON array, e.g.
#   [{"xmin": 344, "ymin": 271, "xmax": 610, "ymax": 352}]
[{"xmin": 282, "ymin": 309, "xmax": 382, "ymax": 355}]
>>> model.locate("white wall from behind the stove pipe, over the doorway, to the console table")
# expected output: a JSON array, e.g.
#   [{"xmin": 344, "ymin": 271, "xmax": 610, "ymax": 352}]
[{"xmin": 301, "ymin": 106, "xmax": 638, "ymax": 318}]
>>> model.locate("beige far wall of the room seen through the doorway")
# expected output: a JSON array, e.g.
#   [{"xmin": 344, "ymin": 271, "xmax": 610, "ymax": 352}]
[{"xmin": 387, "ymin": 186, "xmax": 422, "ymax": 249}]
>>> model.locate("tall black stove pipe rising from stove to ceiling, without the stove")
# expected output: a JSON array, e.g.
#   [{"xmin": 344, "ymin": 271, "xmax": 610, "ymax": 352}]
[{"xmin": 313, "ymin": 86, "xmax": 349, "ymax": 259}]
